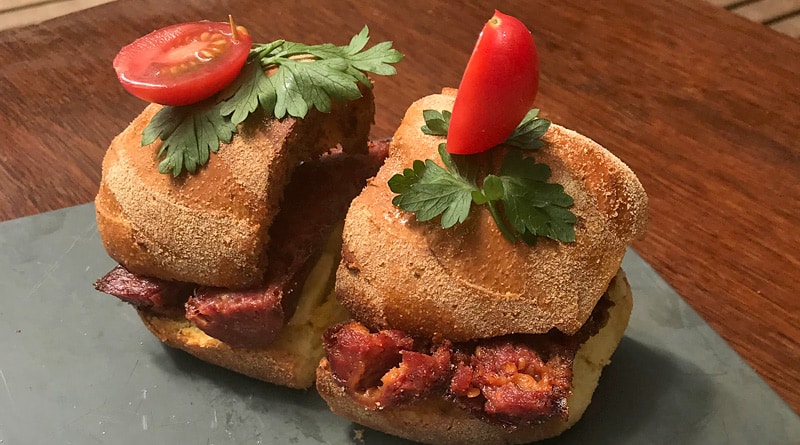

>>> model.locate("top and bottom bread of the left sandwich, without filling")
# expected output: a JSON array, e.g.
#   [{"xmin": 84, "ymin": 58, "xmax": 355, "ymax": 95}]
[{"xmin": 95, "ymin": 80, "xmax": 374, "ymax": 388}]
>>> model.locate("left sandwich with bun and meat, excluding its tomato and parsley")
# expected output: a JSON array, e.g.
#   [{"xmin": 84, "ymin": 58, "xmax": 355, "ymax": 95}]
[{"xmin": 95, "ymin": 87, "xmax": 386, "ymax": 388}]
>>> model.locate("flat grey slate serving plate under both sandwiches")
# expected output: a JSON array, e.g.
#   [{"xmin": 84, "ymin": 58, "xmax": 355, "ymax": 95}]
[{"xmin": 0, "ymin": 204, "xmax": 800, "ymax": 445}]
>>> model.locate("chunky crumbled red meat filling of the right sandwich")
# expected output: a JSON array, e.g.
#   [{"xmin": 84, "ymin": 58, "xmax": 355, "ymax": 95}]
[{"xmin": 323, "ymin": 278, "xmax": 618, "ymax": 427}]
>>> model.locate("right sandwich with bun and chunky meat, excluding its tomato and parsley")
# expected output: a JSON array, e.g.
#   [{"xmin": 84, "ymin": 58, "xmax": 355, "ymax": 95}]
[{"xmin": 316, "ymin": 89, "xmax": 647, "ymax": 444}]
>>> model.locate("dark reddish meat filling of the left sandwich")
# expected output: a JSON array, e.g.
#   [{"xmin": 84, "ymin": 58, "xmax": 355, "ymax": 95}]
[{"xmin": 95, "ymin": 142, "xmax": 388, "ymax": 348}]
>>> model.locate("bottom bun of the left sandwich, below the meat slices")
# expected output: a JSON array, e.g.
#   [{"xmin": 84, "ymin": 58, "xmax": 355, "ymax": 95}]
[{"xmin": 139, "ymin": 230, "xmax": 348, "ymax": 388}]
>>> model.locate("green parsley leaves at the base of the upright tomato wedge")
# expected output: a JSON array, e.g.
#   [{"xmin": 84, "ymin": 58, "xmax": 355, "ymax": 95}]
[{"xmin": 389, "ymin": 109, "xmax": 577, "ymax": 245}]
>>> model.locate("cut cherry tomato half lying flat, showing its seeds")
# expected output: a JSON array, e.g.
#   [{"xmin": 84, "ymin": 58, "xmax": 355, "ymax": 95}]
[{"xmin": 114, "ymin": 22, "xmax": 253, "ymax": 105}]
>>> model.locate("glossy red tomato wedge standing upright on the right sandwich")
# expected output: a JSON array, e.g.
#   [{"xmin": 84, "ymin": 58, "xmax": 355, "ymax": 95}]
[{"xmin": 447, "ymin": 11, "xmax": 539, "ymax": 154}]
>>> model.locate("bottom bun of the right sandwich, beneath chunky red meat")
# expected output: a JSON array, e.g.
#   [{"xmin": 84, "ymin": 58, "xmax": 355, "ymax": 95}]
[{"xmin": 317, "ymin": 269, "xmax": 633, "ymax": 445}]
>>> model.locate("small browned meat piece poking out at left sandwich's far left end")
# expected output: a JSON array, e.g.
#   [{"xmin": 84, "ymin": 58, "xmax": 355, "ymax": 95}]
[{"xmin": 94, "ymin": 265, "xmax": 194, "ymax": 315}]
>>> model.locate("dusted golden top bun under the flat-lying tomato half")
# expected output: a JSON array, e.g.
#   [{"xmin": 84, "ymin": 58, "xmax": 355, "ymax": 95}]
[{"xmin": 95, "ymin": 87, "xmax": 374, "ymax": 288}]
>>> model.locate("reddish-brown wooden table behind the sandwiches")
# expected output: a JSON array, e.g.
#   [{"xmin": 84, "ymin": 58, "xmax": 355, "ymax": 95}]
[{"xmin": 0, "ymin": 0, "xmax": 800, "ymax": 411}]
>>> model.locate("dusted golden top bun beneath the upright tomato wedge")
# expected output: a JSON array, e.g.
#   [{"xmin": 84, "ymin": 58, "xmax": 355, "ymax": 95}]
[{"xmin": 336, "ymin": 89, "xmax": 647, "ymax": 341}]
